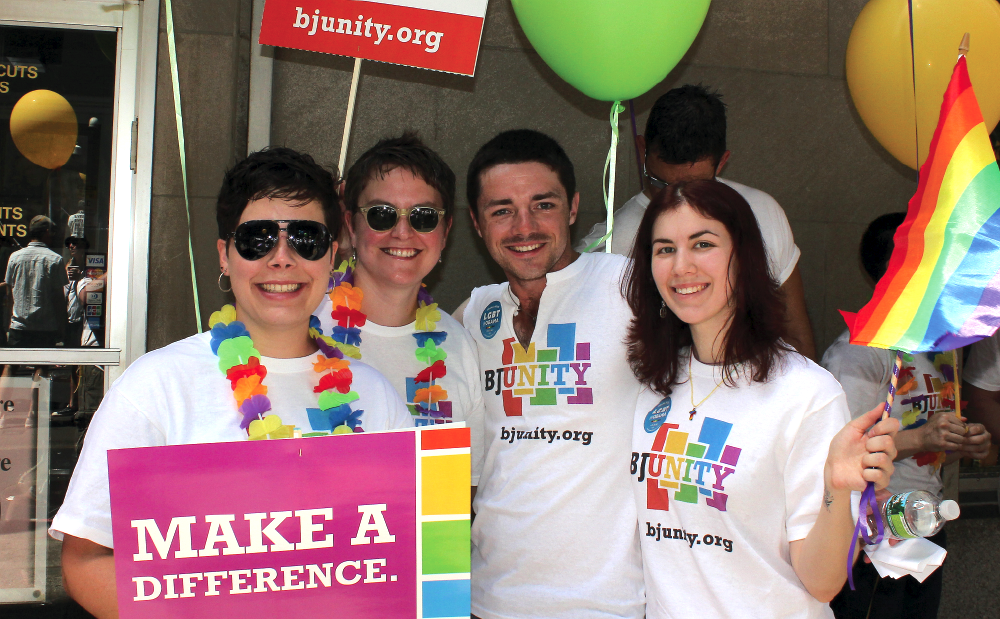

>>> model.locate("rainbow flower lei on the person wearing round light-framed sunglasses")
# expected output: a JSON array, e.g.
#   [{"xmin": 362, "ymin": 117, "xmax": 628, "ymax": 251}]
[{"xmin": 324, "ymin": 261, "xmax": 448, "ymax": 424}]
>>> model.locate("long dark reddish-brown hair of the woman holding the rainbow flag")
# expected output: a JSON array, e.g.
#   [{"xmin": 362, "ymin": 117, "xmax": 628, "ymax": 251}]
[{"xmin": 622, "ymin": 180, "xmax": 790, "ymax": 395}]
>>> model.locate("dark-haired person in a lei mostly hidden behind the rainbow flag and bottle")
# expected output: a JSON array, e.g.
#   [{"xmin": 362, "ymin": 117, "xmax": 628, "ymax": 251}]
[{"xmin": 822, "ymin": 213, "xmax": 990, "ymax": 619}]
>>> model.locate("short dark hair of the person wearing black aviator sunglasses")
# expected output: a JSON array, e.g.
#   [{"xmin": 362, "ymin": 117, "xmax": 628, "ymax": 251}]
[{"xmin": 215, "ymin": 147, "xmax": 341, "ymax": 240}]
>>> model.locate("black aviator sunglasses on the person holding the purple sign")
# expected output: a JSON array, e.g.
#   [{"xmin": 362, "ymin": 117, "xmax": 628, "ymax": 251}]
[{"xmin": 229, "ymin": 219, "xmax": 333, "ymax": 260}]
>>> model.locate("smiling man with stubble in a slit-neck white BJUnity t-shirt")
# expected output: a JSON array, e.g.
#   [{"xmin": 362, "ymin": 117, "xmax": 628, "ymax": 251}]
[{"xmin": 463, "ymin": 130, "xmax": 645, "ymax": 619}]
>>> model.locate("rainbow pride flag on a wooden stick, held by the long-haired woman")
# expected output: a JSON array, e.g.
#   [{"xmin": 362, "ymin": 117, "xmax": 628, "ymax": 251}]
[{"xmin": 841, "ymin": 55, "xmax": 1000, "ymax": 352}]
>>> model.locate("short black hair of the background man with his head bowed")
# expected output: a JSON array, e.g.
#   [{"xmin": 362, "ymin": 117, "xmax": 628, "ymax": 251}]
[{"xmin": 645, "ymin": 84, "xmax": 726, "ymax": 165}]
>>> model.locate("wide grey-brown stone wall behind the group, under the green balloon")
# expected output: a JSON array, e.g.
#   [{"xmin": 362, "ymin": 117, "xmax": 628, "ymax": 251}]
[{"xmin": 271, "ymin": 0, "xmax": 916, "ymax": 351}]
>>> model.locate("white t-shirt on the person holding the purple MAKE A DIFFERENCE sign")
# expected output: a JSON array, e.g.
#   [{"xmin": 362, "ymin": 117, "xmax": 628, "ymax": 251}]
[{"xmin": 49, "ymin": 332, "xmax": 413, "ymax": 548}]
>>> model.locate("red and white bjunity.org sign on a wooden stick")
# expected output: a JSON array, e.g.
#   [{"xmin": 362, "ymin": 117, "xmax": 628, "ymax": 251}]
[{"xmin": 260, "ymin": 0, "xmax": 487, "ymax": 75}]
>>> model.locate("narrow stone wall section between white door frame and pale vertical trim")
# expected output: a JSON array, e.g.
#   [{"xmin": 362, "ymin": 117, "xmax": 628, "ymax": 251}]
[{"xmin": 146, "ymin": 0, "xmax": 251, "ymax": 350}]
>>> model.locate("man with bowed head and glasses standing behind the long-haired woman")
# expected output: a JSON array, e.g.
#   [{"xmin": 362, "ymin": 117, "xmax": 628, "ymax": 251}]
[{"xmin": 577, "ymin": 84, "xmax": 816, "ymax": 360}]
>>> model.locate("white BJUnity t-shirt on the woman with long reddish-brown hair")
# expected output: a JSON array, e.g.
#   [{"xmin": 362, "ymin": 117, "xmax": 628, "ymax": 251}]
[{"xmin": 631, "ymin": 353, "xmax": 849, "ymax": 619}]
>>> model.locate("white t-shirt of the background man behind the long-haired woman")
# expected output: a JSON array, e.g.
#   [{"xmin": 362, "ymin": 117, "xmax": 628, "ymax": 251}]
[{"xmin": 577, "ymin": 178, "xmax": 801, "ymax": 284}]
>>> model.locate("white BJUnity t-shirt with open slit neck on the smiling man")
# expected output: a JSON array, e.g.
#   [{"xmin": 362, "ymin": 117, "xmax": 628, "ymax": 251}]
[{"xmin": 465, "ymin": 254, "xmax": 644, "ymax": 619}]
